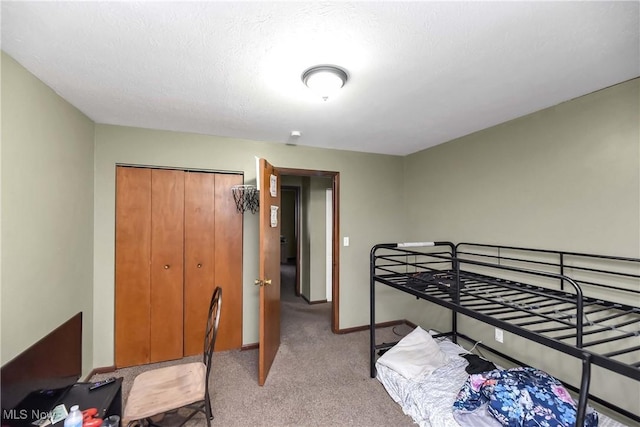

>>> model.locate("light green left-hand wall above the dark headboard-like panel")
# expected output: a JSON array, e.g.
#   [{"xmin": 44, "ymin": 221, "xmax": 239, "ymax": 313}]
[{"xmin": 1, "ymin": 53, "xmax": 94, "ymax": 374}]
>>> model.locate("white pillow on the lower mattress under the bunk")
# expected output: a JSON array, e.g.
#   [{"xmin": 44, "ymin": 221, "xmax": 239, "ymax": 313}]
[{"xmin": 376, "ymin": 326, "xmax": 449, "ymax": 379}]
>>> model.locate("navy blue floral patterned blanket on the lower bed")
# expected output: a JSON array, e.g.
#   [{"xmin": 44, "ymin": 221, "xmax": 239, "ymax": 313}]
[{"xmin": 453, "ymin": 367, "xmax": 598, "ymax": 427}]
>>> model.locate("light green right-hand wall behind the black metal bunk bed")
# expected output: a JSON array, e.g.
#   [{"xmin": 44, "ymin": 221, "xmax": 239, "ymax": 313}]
[{"xmin": 403, "ymin": 79, "xmax": 640, "ymax": 422}]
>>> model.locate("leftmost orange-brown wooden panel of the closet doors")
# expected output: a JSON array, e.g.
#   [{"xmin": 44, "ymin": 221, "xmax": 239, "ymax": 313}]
[{"xmin": 115, "ymin": 166, "xmax": 151, "ymax": 368}]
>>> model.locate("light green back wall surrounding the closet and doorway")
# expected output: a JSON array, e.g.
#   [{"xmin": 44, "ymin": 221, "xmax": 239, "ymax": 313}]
[{"xmin": 94, "ymin": 125, "xmax": 404, "ymax": 366}]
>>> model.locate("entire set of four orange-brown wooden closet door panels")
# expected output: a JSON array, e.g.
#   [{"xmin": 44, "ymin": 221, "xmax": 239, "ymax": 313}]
[{"xmin": 115, "ymin": 166, "xmax": 242, "ymax": 367}]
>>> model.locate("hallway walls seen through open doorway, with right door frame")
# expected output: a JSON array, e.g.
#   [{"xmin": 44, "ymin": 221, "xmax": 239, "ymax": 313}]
[{"xmin": 278, "ymin": 168, "xmax": 340, "ymax": 333}]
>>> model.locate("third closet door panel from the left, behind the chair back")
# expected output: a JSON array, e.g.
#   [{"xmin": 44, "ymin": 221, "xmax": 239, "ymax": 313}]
[{"xmin": 184, "ymin": 172, "xmax": 216, "ymax": 356}]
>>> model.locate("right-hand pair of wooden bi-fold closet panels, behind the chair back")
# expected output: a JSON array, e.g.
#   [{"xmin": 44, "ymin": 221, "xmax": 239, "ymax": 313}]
[{"xmin": 184, "ymin": 172, "xmax": 242, "ymax": 356}]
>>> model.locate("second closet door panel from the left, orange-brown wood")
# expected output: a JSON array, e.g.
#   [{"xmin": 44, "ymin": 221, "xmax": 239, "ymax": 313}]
[{"xmin": 150, "ymin": 169, "xmax": 184, "ymax": 363}]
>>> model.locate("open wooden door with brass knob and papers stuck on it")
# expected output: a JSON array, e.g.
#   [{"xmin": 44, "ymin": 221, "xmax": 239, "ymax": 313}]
[{"xmin": 256, "ymin": 159, "xmax": 281, "ymax": 385}]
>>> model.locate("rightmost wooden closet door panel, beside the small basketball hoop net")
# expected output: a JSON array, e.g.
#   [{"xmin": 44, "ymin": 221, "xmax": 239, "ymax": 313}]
[{"xmin": 215, "ymin": 174, "xmax": 244, "ymax": 351}]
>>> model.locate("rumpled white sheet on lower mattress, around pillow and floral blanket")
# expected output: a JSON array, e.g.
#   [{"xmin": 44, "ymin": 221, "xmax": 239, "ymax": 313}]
[{"xmin": 376, "ymin": 340, "xmax": 624, "ymax": 427}]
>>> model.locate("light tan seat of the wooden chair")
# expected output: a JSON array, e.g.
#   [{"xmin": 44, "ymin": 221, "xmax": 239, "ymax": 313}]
[{"xmin": 122, "ymin": 362, "xmax": 206, "ymax": 426}]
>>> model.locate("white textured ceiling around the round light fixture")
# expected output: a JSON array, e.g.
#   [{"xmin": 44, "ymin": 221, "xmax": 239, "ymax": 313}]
[{"xmin": 1, "ymin": 1, "xmax": 640, "ymax": 155}]
